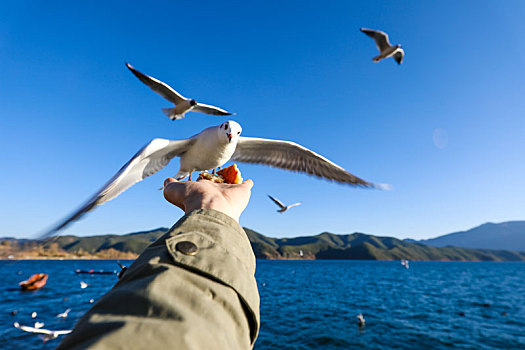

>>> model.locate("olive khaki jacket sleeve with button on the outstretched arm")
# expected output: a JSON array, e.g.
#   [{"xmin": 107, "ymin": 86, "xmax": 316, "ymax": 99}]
[{"xmin": 58, "ymin": 209, "xmax": 260, "ymax": 349}]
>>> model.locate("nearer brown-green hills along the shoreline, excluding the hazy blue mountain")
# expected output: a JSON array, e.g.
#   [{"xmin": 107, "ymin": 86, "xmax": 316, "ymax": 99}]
[{"xmin": 4, "ymin": 225, "xmax": 525, "ymax": 261}]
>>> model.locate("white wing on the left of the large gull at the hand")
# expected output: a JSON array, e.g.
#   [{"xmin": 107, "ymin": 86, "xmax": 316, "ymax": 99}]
[{"xmin": 40, "ymin": 138, "xmax": 196, "ymax": 238}]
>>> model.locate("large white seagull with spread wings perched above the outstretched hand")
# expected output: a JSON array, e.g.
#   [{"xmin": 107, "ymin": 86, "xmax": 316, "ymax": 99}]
[{"xmin": 41, "ymin": 120, "xmax": 389, "ymax": 238}]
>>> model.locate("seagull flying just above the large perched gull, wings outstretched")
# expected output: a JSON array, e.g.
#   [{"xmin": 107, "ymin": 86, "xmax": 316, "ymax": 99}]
[{"xmin": 126, "ymin": 63, "xmax": 232, "ymax": 120}]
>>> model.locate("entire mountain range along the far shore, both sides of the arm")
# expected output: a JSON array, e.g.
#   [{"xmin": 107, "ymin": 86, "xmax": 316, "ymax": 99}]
[{"xmin": 4, "ymin": 221, "xmax": 525, "ymax": 261}]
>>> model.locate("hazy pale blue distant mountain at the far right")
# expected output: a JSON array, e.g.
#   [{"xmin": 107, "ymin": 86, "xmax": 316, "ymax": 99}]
[{"xmin": 419, "ymin": 221, "xmax": 525, "ymax": 252}]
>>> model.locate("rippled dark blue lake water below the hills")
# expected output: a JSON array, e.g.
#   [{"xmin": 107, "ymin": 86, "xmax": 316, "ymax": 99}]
[{"xmin": 0, "ymin": 260, "xmax": 525, "ymax": 350}]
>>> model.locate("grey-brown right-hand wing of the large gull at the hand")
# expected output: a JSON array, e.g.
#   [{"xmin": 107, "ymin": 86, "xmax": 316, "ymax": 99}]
[{"xmin": 232, "ymin": 137, "xmax": 377, "ymax": 187}]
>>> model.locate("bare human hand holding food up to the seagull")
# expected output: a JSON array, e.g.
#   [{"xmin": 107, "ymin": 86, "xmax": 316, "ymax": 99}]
[{"xmin": 164, "ymin": 178, "xmax": 253, "ymax": 222}]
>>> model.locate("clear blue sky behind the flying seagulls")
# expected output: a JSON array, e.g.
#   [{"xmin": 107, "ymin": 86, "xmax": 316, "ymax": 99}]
[{"xmin": 0, "ymin": 1, "xmax": 525, "ymax": 239}]
